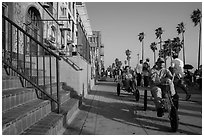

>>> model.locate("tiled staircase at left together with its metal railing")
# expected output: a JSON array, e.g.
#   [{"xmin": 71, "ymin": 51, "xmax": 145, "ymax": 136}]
[{"xmin": 2, "ymin": 16, "xmax": 81, "ymax": 135}]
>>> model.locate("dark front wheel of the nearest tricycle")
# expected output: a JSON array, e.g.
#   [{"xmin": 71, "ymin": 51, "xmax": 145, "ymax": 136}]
[{"xmin": 170, "ymin": 106, "xmax": 179, "ymax": 132}]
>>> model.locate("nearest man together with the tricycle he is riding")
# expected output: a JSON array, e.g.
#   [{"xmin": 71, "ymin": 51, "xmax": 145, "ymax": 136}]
[{"xmin": 150, "ymin": 58, "xmax": 179, "ymax": 131}]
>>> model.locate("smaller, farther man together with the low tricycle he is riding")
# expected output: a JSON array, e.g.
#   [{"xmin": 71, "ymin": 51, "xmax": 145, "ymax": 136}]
[{"xmin": 116, "ymin": 66, "xmax": 140, "ymax": 101}]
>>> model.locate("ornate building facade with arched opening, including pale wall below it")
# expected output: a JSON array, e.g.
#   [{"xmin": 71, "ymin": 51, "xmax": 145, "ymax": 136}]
[{"xmin": 2, "ymin": 2, "xmax": 93, "ymax": 94}]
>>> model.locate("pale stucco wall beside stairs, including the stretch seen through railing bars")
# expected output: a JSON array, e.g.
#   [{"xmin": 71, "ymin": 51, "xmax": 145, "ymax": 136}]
[{"xmin": 27, "ymin": 56, "xmax": 94, "ymax": 96}]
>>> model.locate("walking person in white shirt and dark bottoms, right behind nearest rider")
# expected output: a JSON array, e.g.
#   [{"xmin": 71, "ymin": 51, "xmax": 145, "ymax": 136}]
[{"xmin": 171, "ymin": 53, "xmax": 191, "ymax": 101}]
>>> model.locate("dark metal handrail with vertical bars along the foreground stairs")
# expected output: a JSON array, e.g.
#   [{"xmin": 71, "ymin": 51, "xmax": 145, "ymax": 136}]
[{"xmin": 2, "ymin": 15, "xmax": 61, "ymax": 113}]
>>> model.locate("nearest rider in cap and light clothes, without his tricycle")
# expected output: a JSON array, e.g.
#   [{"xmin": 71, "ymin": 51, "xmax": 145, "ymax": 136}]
[{"xmin": 150, "ymin": 58, "xmax": 177, "ymax": 117}]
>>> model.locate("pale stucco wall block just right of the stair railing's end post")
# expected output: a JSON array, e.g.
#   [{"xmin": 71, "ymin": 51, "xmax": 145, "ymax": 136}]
[{"xmin": 60, "ymin": 56, "xmax": 94, "ymax": 96}]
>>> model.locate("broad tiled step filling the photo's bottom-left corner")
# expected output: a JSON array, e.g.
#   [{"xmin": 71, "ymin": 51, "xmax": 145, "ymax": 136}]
[{"xmin": 2, "ymin": 99, "xmax": 51, "ymax": 135}]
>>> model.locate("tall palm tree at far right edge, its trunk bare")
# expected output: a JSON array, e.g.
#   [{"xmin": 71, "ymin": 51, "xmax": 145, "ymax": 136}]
[{"xmin": 191, "ymin": 9, "xmax": 202, "ymax": 69}]
